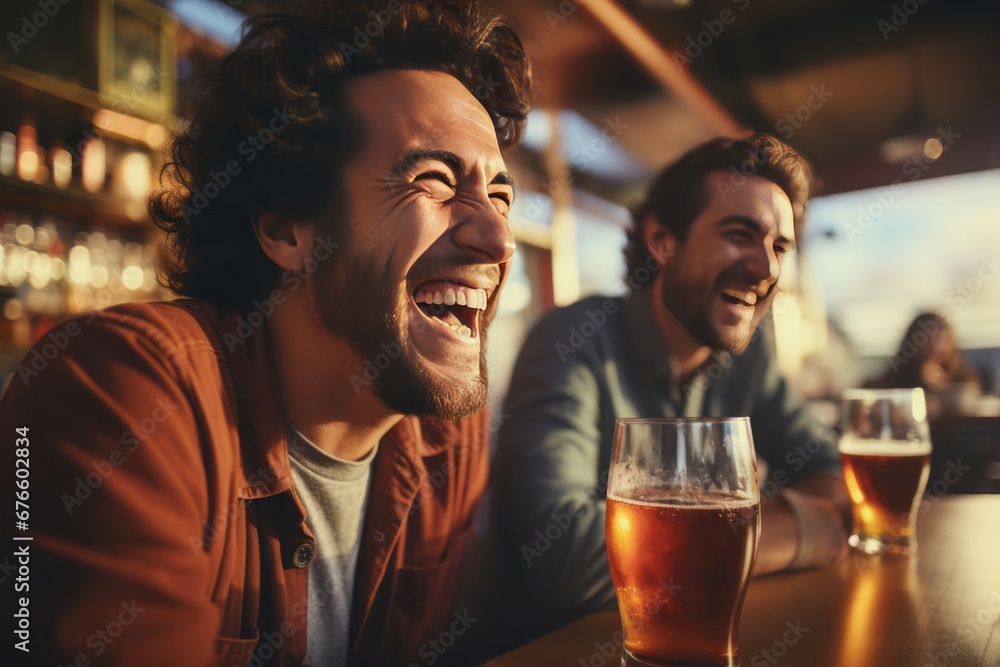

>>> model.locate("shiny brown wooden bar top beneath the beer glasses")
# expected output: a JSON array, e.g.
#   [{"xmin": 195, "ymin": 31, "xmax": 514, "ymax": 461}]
[{"xmin": 483, "ymin": 495, "xmax": 1000, "ymax": 667}]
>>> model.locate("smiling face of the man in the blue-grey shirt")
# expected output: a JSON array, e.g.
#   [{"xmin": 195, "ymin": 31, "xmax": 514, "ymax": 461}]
[{"xmin": 662, "ymin": 172, "xmax": 795, "ymax": 353}]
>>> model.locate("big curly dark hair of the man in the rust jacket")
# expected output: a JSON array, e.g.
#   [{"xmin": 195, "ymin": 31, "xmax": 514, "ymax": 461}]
[{"xmin": 149, "ymin": 0, "xmax": 530, "ymax": 310}]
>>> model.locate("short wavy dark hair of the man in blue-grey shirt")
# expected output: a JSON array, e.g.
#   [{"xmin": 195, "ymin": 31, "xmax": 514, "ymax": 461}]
[{"xmin": 625, "ymin": 132, "xmax": 812, "ymax": 285}]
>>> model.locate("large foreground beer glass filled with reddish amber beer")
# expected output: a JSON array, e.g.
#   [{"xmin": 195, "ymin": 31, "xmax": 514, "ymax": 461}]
[{"xmin": 607, "ymin": 417, "xmax": 760, "ymax": 667}]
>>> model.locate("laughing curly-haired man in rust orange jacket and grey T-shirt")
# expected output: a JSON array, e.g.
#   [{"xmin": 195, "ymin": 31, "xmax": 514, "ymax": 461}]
[{"xmin": 0, "ymin": 0, "xmax": 529, "ymax": 667}]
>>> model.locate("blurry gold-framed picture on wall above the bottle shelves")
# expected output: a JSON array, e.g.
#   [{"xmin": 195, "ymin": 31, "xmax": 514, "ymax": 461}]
[{"xmin": 98, "ymin": 0, "xmax": 177, "ymax": 118}]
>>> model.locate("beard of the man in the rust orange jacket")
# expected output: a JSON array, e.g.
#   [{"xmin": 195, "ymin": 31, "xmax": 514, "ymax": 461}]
[{"xmin": 315, "ymin": 244, "xmax": 488, "ymax": 421}]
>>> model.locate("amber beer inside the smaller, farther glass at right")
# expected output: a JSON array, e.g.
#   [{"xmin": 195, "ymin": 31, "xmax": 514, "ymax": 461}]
[{"xmin": 839, "ymin": 438, "xmax": 931, "ymax": 542}]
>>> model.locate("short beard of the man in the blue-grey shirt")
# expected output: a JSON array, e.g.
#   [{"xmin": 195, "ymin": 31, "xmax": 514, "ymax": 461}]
[{"xmin": 663, "ymin": 263, "xmax": 774, "ymax": 354}]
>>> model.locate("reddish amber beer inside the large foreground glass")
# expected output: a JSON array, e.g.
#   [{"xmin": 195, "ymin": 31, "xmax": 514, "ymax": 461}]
[{"xmin": 607, "ymin": 490, "xmax": 760, "ymax": 666}]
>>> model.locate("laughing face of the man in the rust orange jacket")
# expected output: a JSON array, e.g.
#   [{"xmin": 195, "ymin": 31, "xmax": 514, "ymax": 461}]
[{"xmin": 316, "ymin": 70, "xmax": 514, "ymax": 419}]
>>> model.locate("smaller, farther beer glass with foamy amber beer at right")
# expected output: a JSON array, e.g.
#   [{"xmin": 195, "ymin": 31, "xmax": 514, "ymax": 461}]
[{"xmin": 839, "ymin": 388, "xmax": 931, "ymax": 555}]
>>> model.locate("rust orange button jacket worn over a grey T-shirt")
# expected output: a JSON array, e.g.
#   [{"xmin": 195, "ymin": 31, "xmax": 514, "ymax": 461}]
[{"xmin": 0, "ymin": 300, "xmax": 489, "ymax": 667}]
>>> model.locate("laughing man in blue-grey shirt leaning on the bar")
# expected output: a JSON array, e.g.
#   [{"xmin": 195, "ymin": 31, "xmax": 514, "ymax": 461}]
[{"xmin": 494, "ymin": 134, "xmax": 847, "ymax": 631}]
